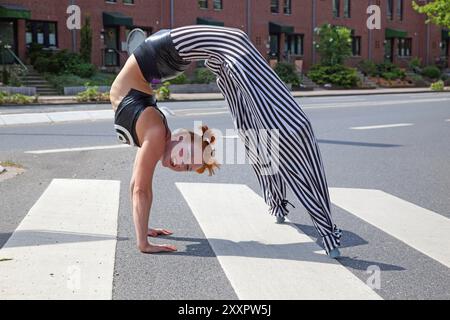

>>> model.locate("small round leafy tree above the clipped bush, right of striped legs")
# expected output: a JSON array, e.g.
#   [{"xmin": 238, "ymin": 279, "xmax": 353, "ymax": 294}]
[{"xmin": 314, "ymin": 24, "xmax": 352, "ymax": 66}]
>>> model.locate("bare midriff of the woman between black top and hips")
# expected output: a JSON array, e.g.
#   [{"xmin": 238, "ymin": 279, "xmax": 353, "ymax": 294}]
[{"xmin": 109, "ymin": 55, "xmax": 153, "ymax": 112}]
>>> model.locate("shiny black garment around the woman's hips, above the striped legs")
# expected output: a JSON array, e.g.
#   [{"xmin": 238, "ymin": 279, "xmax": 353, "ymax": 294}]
[{"xmin": 134, "ymin": 29, "xmax": 190, "ymax": 82}]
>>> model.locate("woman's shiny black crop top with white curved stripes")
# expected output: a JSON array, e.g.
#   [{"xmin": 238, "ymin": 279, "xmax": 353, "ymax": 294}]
[{"xmin": 114, "ymin": 89, "xmax": 169, "ymax": 147}]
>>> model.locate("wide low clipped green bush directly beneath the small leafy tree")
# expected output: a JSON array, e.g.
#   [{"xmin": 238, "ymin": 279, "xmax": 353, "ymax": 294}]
[{"xmin": 308, "ymin": 64, "xmax": 359, "ymax": 88}]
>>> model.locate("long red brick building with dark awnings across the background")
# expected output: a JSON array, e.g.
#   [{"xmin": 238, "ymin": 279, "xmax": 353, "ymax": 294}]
[{"xmin": 0, "ymin": 0, "xmax": 449, "ymax": 68}]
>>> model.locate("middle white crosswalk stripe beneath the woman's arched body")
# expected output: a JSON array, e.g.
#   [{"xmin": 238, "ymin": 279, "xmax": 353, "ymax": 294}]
[{"xmin": 176, "ymin": 183, "xmax": 381, "ymax": 300}]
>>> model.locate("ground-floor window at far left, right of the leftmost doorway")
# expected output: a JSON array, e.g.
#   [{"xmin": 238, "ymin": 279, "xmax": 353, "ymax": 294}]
[{"xmin": 25, "ymin": 21, "xmax": 58, "ymax": 48}]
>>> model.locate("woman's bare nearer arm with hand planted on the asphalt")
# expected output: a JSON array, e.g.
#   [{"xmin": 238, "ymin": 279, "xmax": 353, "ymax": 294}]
[{"xmin": 131, "ymin": 129, "xmax": 176, "ymax": 253}]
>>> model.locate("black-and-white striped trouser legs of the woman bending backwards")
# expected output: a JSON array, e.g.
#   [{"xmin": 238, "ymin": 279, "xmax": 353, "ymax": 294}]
[{"xmin": 171, "ymin": 25, "xmax": 341, "ymax": 253}]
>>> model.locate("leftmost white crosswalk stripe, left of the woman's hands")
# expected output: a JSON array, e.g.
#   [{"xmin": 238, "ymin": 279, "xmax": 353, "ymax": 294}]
[{"xmin": 0, "ymin": 179, "xmax": 120, "ymax": 300}]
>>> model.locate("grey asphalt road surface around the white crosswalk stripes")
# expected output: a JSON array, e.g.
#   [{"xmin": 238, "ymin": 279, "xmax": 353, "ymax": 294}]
[{"xmin": 0, "ymin": 93, "xmax": 450, "ymax": 299}]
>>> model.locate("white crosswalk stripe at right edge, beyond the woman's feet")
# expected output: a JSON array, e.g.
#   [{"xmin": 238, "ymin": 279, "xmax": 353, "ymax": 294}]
[{"xmin": 330, "ymin": 188, "xmax": 450, "ymax": 267}]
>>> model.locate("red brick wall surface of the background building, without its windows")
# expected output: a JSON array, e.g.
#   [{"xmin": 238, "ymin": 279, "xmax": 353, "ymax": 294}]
[{"xmin": 7, "ymin": 0, "xmax": 441, "ymax": 68}]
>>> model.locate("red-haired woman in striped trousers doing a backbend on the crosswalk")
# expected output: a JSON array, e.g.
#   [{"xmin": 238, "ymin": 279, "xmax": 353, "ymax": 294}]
[{"xmin": 110, "ymin": 25, "xmax": 341, "ymax": 258}]
